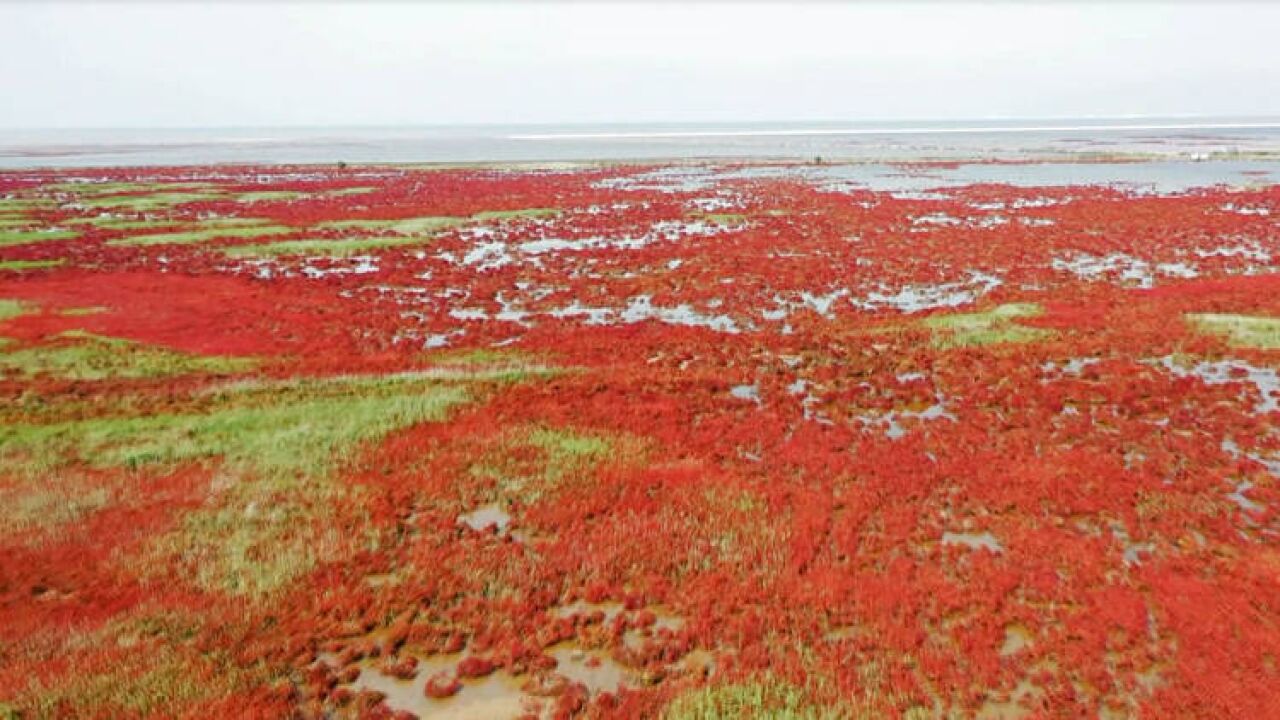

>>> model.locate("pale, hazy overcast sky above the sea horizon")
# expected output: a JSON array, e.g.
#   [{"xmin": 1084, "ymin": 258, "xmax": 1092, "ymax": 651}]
[{"xmin": 0, "ymin": 0, "xmax": 1280, "ymax": 128}]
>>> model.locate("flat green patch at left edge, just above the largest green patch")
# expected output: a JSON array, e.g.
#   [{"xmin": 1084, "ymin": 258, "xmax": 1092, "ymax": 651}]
[{"xmin": 0, "ymin": 332, "xmax": 256, "ymax": 380}]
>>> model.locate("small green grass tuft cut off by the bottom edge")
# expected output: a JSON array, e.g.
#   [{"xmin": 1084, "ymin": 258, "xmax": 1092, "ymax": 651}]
[{"xmin": 662, "ymin": 678, "xmax": 869, "ymax": 720}]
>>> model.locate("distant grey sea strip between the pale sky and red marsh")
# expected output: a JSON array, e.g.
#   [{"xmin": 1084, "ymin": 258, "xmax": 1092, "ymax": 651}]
[{"xmin": 0, "ymin": 118, "xmax": 1280, "ymax": 168}]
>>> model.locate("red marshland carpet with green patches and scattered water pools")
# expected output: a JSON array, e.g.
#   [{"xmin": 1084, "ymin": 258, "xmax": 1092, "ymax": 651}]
[{"xmin": 0, "ymin": 164, "xmax": 1280, "ymax": 720}]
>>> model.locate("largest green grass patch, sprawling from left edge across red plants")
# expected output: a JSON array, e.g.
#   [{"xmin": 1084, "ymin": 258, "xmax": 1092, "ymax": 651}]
[{"xmin": 0, "ymin": 377, "xmax": 468, "ymax": 593}]
